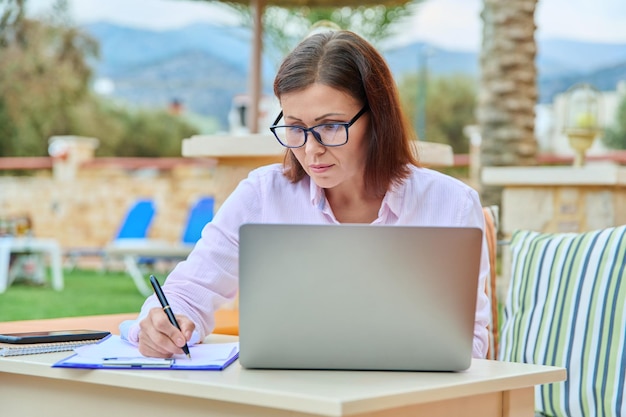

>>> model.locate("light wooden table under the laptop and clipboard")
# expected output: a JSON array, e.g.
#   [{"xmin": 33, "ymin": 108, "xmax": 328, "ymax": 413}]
[{"xmin": 0, "ymin": 318, "xmax": 566, "ymax": 417}]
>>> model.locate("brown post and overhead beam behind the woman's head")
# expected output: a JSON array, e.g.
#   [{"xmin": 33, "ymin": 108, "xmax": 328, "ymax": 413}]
[{"xmin": 185, "ymin": 0, "xmax": 412, "ymax": 133}]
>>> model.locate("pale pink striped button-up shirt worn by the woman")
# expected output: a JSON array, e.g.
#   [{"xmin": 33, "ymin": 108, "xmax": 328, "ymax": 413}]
[{"xmin": 120, "ymin": 164, "xmax": 490, "ymax": 358}]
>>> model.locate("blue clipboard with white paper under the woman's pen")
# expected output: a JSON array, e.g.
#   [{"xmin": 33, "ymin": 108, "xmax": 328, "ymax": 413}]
[{"xmin": 52, "ymin": 335, "xmax": 239, "ymax": 371}]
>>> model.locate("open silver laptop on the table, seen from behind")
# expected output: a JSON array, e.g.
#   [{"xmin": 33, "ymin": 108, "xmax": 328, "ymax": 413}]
[{"xmin": 239, "ymin": 224, "xmax": 482, "ymax": 371}]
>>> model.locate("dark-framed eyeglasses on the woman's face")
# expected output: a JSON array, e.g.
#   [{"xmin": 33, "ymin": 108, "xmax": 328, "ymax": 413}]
[{"xmin": 270, "ymin": 104, "xmax": 369, "ymax": 148}]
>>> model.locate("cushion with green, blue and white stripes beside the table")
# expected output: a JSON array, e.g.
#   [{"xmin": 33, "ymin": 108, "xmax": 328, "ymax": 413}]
[{"xmin": 499, "ymin": 226, "xmax": 626, "ymax": 416}]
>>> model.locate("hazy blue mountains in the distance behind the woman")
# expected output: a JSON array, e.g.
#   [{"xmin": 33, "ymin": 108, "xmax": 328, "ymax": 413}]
[{"xmin": 84, "ymin": 22, "xmax": 626, "ymax": 128}]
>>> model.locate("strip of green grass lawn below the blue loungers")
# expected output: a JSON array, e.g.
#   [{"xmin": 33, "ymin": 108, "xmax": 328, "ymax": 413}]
[{"xmin": 0, "ymin": 270, "xmax": 165, "ymax": 322}]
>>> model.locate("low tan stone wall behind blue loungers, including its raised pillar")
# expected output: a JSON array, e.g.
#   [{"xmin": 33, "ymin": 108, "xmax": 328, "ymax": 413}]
[{"xmin": 0, "ymin": 136, "xmax": 258, "ymax": 250}]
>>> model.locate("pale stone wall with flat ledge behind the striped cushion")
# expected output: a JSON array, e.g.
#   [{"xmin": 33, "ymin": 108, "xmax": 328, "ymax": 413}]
[{"xmin": 482, "ymin": 162, "xmax": 626, "ymax": 239}]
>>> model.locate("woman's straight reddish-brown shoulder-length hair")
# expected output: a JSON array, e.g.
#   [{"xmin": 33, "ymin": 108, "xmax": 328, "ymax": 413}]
[{"xmin": 274, "ymin": 31, "xmax": 418, "ymax": 196}]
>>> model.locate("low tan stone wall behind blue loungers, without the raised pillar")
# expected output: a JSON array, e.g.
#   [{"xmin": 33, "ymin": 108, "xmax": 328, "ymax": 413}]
[{"xmin": 0, "ymin": 165, "xmax": 255, "ymax": 249}]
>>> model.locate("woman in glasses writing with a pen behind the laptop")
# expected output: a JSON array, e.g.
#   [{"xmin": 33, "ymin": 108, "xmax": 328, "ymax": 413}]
[{"xmin": 122, "ymin": 31, "xmax": 489, "ymax": 358}]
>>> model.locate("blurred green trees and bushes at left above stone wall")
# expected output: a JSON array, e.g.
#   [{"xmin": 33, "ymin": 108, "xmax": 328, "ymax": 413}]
[{"xmin": 0, "ymin": 0, "xmax": 197, "ymax": 157}]
